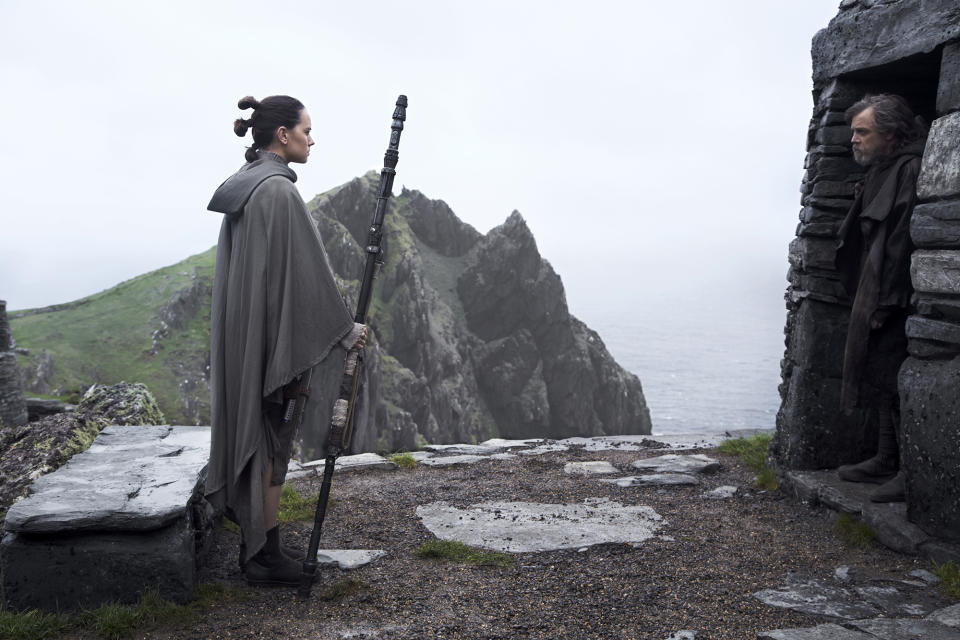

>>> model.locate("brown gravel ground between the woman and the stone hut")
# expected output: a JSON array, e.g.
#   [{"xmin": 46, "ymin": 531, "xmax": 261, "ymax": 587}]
[{"xmin": 141, "ymin": 450, "xmax": 944, "ymax": 640}]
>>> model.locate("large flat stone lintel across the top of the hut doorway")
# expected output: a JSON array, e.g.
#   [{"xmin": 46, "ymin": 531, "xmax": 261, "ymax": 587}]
[{"xmin": 811, "ymin": 0, "xmax": 960, "ymax": 84}]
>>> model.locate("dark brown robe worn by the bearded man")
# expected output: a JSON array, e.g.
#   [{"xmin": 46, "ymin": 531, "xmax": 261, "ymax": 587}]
[{"xmin": 836, "ymin": 140, "xmax": 924, "ymax": 410}]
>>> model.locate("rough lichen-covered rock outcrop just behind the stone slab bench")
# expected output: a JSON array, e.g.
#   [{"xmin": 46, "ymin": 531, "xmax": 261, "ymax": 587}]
[{"xmin": 0, "ymin": 382, "xmax": 166, "ymax": 518}]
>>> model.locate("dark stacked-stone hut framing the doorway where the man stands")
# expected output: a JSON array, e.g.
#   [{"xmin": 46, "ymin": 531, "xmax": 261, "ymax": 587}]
[{"xmin": 771, "ymin": 0, "xmax": 960, "ymax": 540}]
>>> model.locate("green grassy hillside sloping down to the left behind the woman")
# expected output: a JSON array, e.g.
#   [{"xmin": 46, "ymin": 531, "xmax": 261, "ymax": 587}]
[{"xmin": 9, "ymin": 247, "xmax": 216, "ymax": 424}]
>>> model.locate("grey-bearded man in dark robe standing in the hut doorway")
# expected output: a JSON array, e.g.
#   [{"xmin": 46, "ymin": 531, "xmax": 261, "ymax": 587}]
[{"xmin": 836, "ymin": 94, "xmax": 926, "ymax": 502}]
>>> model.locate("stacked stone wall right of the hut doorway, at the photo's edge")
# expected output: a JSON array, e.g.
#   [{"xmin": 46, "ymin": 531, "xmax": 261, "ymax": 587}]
[{"xmin": 899, "ymin": 42, "xmax": 960, "ymax": 539}]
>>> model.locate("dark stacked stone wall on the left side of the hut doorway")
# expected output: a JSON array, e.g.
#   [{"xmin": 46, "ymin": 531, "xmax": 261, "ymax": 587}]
[{"xmin": 772, "ymin": 80, "xmax": 876, "ymax": 469}]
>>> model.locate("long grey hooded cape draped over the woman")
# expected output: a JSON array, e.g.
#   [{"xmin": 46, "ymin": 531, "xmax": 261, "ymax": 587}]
[{"xmin": 206, "ymin": 154, "xmax": 353, "ymax": 560}]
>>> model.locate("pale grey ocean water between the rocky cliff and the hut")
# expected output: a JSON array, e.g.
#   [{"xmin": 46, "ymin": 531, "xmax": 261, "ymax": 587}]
[{"xmin": 584, "ymin": 299, "xmax": 786, "ymax": 433}]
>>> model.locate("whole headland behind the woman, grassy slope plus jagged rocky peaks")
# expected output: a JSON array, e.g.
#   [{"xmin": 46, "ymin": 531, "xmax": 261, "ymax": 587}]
[{"xmin": 13, "ymin": 173, "xmax": 650, "ymax": 455}]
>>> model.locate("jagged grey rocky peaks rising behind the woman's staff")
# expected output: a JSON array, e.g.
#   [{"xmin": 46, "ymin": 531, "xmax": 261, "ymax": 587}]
[{"xmin": 310, "ymin": 173, "xmax": 650, "ymax": 450}]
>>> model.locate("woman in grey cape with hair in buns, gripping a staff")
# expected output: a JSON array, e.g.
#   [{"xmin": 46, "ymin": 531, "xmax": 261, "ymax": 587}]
[{"xmin": 206, "ymin": 96, "xmax": 366, "ymax": 586}]
